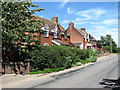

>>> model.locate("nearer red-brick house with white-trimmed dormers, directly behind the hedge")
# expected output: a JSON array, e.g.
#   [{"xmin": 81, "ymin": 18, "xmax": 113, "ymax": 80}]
[{"xmin": 36, "ymin": 16, "xmax": 70, "ymax": 46}]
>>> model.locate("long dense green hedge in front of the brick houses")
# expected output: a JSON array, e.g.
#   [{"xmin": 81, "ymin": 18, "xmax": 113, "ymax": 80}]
[{"xmin": 29, "ymin": 45, "xmax": 95, "ymax": 71}]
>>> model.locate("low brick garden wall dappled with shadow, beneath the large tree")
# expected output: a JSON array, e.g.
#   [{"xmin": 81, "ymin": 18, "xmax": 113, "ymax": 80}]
[{"xmin": 2, "ymin": 61, "xmax": 30, "ymax": 74}]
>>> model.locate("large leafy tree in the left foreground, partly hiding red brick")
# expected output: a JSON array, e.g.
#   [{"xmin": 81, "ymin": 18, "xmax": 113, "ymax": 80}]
[{"xmin": 1, "ymin": 2, "xmax": 44, "ymax": 60}]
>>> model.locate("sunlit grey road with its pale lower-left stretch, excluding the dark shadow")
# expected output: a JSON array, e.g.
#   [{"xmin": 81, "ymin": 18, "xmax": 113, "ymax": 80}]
[{"xmin": 3, "ymin": 55, "xmax": 118, "ymax": 88}]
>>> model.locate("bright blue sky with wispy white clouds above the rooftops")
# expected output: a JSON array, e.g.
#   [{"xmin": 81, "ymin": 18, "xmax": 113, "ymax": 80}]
[{"xmin": 31, "ymin": 0, "xmax": 118, "ymax": 44}]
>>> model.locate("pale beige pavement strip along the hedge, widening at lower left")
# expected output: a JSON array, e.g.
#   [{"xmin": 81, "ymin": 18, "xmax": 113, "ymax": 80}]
[{"xmin": 0, "ymin": 54, "xmax": 118, "ymax": 88}]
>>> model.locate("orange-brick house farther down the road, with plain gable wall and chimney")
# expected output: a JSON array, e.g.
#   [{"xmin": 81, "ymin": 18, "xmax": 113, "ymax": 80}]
[{"xmin": 66, "ymin": 22, "xmax": 97, "ymax": 49}]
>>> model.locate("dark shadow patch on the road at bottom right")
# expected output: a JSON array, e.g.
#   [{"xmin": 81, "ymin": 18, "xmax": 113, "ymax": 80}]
[{"xmin": 99, "ymin": 77, "xmax": 120, "ymax": 90}]
